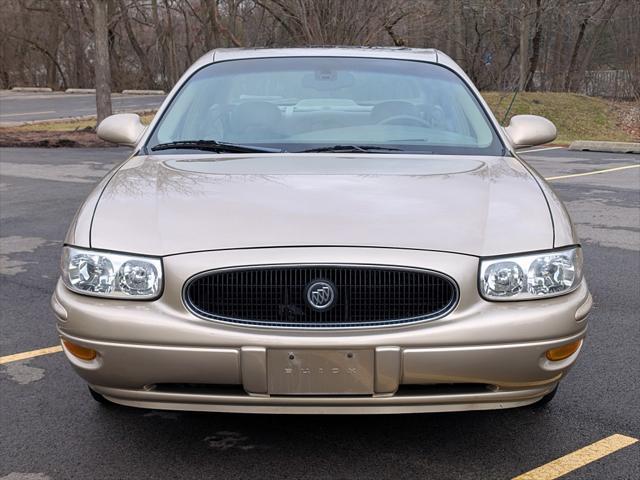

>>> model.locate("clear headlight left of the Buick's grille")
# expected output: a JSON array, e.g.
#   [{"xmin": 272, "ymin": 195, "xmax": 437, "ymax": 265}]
[{"xmin": 62, "ymin": 247, "xmax": 162, "ymax": 300}]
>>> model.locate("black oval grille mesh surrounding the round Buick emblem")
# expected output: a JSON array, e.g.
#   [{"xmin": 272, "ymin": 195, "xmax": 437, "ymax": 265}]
[{"xmin": 185, "ymin": 265, "xmax": 457, "ymax": 328}]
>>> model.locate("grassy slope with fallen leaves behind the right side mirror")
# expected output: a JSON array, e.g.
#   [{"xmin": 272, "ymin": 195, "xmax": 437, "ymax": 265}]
[{"xmin": 482, "ymin": 92, "xmax": 634, "ymax": 143}]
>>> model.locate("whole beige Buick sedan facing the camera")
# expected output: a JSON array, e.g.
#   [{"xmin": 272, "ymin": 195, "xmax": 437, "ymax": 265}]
[{"xmin": 52, "ymin": 48, "xmax": 592, "ymax": 413}]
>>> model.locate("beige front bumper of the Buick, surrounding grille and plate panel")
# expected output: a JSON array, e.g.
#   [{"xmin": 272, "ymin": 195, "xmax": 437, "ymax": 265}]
[{"xmin": 52, "ymin": 248, "xmax": 592, "ymax": 413}]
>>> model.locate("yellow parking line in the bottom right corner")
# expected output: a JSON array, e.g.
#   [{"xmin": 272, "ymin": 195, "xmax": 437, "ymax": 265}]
[{"xmin": 513, "ymin": 434, "xmax": 638, "ymax": 480}]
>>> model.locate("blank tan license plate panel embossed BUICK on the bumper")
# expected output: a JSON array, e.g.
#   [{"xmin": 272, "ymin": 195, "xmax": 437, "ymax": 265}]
[{"xmin": 267, "ymin": 349, "xmax": 374, "ymax": 395}]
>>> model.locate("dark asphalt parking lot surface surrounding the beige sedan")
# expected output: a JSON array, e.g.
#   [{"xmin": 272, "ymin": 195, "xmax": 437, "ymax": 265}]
[{"xmin": 0, "ymin": 148, "xmax": 640, "ymax": 480}]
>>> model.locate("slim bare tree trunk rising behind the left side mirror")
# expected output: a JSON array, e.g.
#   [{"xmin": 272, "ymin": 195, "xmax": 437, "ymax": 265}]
[{"xmin": 93, "ymin": 0, "xmax": 111, "ymax": 124}]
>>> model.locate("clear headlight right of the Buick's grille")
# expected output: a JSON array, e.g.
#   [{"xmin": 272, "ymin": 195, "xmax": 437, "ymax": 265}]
[{"xmin": 479, "ymin": 247, "xmax": 582, "ymax": 300}]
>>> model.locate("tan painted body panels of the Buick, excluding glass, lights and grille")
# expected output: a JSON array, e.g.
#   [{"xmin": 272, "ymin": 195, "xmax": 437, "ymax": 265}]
[{"xmin": 52, "ymin": 48, "xmax": 592, "ymax": 413}]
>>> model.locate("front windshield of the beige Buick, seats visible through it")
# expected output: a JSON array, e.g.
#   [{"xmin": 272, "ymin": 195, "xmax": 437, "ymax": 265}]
[{"xmin": 147, "ymin": 57, "xmax": 503, "ymax": 155}]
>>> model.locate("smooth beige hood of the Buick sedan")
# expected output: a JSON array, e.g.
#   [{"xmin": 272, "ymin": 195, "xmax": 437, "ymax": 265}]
[{"xmin": 91, "ymin": 154, "xmax": 553, "ymax": 256}]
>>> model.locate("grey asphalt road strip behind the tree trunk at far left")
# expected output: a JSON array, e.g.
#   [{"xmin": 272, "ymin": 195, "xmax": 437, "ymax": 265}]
[{"xmin": 0, "ymin": 90, "xmax": 165, "ymax": 126}]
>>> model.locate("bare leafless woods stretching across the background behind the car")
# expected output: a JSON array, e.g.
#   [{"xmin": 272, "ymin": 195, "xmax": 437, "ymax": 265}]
[{"xmin": 0, "ymin": 0, "xmax": 640, "ymax": 99}]
